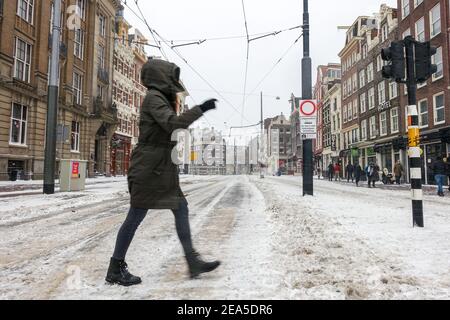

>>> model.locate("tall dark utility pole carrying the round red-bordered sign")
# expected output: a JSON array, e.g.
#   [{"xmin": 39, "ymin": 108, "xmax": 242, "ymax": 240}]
[{"xmin": 302, "ymin": 0, "xmax": 314, "ymax": 196}]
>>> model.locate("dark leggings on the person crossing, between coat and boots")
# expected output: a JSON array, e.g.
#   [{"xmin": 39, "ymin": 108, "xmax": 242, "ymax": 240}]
[{"xmin": 113, "ymin": 200, "xmax": 193, "ymax": 260}]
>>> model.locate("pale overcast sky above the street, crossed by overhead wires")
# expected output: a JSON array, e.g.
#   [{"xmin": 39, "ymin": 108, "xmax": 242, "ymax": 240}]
[{"xmin": 125, "ymin": 0, "xmax": 397, "ymax": 136}]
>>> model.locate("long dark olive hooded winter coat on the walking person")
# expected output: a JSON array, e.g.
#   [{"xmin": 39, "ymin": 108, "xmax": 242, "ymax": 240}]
[{"xmin": 128, "ymin": 59, "xmax": 203, "ymax": 209}]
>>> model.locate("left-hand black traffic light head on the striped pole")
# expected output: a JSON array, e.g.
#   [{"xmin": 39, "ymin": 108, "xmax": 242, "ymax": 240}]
[{"xmin": 381, "ymin": 41, "xmax": 405, "ymax": 82}]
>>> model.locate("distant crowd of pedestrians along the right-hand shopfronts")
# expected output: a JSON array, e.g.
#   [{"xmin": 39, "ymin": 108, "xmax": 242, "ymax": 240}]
[{"xmin": 317, "ymin": 156, "xmax": 450, "ymax": 197}]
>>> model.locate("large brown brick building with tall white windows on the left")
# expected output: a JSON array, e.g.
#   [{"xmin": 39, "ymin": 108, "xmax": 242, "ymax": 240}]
[{"xmin": 0, "ymin": 0, "xmax": 119, "ymax": 180}]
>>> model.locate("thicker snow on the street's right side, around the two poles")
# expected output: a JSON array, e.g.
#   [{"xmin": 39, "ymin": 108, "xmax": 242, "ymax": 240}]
[{"xmin": 255, "ymin": 177, "xmax": 450, "ymax": 299}]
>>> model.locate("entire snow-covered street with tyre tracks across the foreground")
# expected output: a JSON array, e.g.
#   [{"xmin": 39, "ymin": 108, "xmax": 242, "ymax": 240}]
[{"xmin": 0, "ymin": 176, "xmax": 450, "ymax": 299}]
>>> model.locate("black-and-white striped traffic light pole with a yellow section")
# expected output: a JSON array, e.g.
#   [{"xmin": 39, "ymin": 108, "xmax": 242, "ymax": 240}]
[{"xmin": 405, "ymin": 36, "xmax": 424, "ymax": 228}]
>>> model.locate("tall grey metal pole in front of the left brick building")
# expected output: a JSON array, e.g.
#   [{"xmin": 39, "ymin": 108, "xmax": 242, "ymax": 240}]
[{"xmin": 44, "ymin": 0, "xmax": 62, "ymax": 194}]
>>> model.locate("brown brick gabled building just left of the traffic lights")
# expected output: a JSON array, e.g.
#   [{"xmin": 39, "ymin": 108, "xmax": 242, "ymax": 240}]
[{"xmin": 342, "ymin": 5, "xmax": 407, "ymax": 172}]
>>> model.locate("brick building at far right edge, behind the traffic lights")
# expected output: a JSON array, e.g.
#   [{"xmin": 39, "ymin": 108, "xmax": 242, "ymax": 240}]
[{"xmin": 398, "ymin": 0, "xmax": 450, "ymax": 184}]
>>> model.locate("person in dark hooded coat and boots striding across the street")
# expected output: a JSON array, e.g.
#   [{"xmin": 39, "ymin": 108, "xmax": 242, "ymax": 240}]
[{"xmin": 106, "ymin": 59, "xmax": 220, "ymax": 286}]
